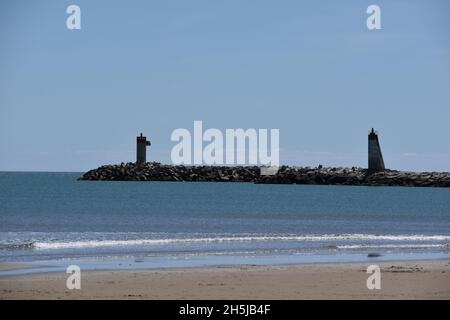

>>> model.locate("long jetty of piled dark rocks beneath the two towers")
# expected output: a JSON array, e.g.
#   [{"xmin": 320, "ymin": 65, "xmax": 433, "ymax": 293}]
[{"xmin": 79, "ymin": 162, "xmax": 450, "ymax": 188}]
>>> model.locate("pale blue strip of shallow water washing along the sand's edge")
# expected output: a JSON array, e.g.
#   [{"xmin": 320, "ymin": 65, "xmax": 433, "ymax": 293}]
[{"xmin": 0, "ymin": 252, "xmax": 450, "ymax": 279}]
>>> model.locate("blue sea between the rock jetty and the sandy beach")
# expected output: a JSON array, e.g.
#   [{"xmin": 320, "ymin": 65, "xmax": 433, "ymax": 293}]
[{"xmin": 0, "ymin": 172, "xmax": 450, "ymax": 274}]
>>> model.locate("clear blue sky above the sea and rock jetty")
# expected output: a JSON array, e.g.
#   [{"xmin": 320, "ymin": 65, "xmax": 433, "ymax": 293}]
[{"xmin": 0, "ymin": 0, "xmax": 450, "ymax": 171}]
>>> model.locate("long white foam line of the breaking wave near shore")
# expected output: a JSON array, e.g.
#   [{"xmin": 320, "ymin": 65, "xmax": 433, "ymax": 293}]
[{"xmin": 34, "ymin": 234, "xmax": 450, "ymax": 249}]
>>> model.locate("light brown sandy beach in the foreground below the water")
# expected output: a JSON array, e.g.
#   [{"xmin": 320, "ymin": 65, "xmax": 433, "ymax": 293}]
[{"xmin": 0, "ymin": 260, "xmax": 450, "ymax": 299}]
